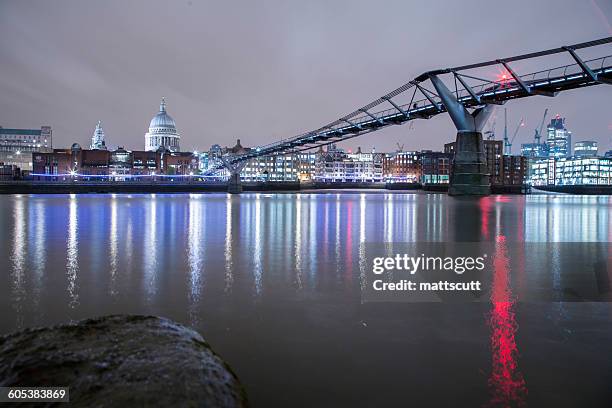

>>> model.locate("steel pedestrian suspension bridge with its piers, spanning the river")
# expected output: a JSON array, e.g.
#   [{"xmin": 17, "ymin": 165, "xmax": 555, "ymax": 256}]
[{"xmin": 207, "ymin": 37, "xmax": 612, "ymax": 195}]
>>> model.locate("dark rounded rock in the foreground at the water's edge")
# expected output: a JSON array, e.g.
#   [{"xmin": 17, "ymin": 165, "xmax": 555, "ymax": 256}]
[{"xmin": 0, "ymin": 316, "xmax": 247, "ymax": 407}]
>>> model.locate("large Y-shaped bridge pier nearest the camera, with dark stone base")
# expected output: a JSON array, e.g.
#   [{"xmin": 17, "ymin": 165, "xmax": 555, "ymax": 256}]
[{"xmin": 429, "ymin": 75, "xmax": 495, "ymax": 196}]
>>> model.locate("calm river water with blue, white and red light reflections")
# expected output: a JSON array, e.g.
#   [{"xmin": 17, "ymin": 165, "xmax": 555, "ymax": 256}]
[{"xmin": 0, "ymin": 192, "xmax": 612, "ymax": 407}]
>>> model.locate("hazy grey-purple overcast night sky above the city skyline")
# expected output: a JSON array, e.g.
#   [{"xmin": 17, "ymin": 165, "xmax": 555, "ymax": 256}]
[{"xmin": 0, "ymin": 0, "xmax": 612, "ymax": 152}]
